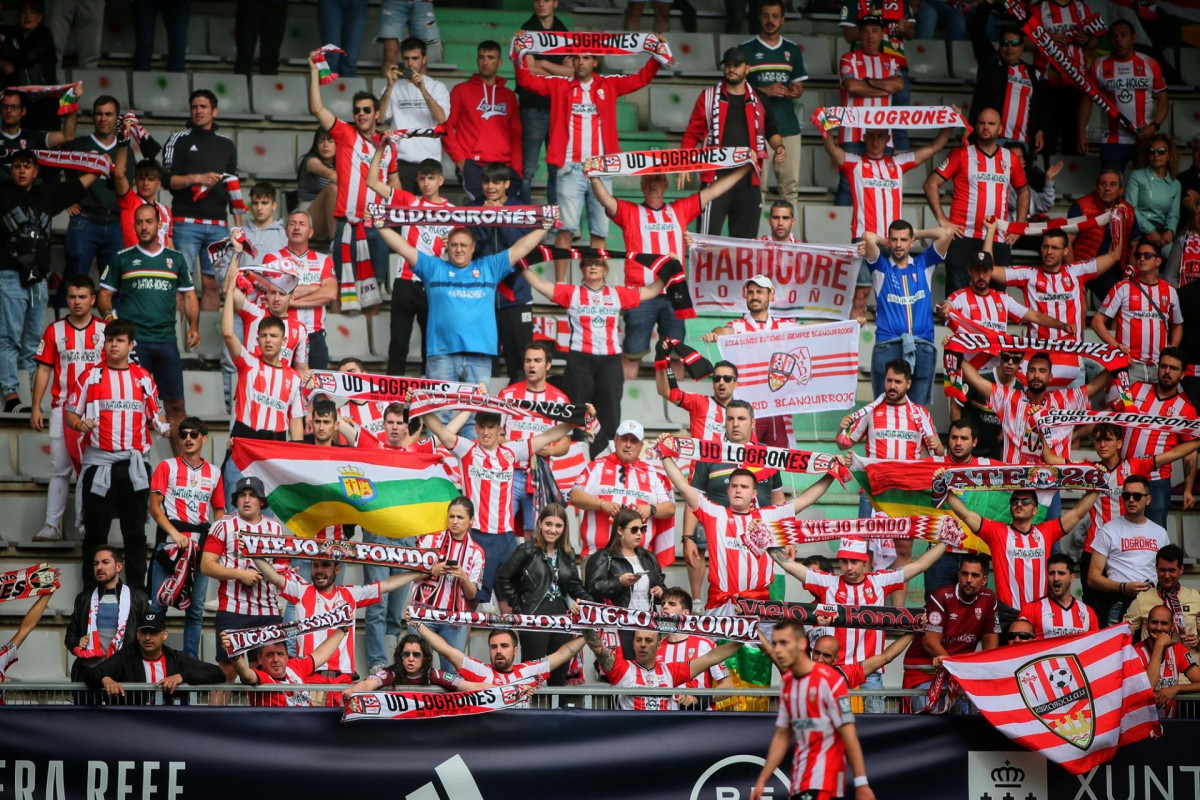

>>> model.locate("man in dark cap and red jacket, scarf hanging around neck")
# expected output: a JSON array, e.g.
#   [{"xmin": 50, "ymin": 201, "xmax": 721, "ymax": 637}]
[{"xmin": 676, "ymin": 47, "xmax": 787, "ymax": 239}]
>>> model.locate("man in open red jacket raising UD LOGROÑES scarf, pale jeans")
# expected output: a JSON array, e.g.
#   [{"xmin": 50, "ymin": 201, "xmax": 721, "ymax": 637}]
[{"xmin": 516, "ymin": 45, "xmax": 659, "ymax": 283}]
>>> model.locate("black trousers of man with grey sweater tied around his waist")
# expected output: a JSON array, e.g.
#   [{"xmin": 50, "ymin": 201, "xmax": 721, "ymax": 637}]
[{"xmin": 79, "ymin": 461, "xmax": 150, "ymax": 591}]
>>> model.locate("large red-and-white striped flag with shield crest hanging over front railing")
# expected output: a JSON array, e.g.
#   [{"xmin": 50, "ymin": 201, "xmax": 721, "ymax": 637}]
[{"xmin": 942, "ymin": 624, "xmax": 1163, "ymax": 775}]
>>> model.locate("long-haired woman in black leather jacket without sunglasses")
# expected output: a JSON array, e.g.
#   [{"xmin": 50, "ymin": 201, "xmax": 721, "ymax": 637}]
[{"xmin": 496, "ymin": 503, "xmax": 592, "ymax": 686}]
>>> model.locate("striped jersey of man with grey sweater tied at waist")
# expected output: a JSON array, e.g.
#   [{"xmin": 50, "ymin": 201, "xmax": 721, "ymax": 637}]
[{"xmin": 66, "ymin": 363, "xmax": 162, "ymax": 453}]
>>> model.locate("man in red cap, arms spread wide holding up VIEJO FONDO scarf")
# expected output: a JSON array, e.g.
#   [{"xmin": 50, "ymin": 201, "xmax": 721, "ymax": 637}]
[{"xmin": 767, "ymin": 537, "xmax": 946, "ymax": 714}]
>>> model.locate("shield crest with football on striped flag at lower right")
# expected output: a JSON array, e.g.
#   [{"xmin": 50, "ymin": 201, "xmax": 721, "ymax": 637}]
[{"xmin": 1015, "ymin": 654, "xmax": 1096, "ymax": 750}]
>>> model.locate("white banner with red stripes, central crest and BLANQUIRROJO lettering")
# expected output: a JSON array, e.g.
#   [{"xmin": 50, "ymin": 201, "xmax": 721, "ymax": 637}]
[{"xmin": 716, "ymin": 320, "xmax": 859, "ymax": 417}]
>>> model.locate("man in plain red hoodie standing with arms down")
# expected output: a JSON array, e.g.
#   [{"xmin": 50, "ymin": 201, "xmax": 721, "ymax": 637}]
[{"xmin": 443, "ymin": 40, "xmax": 522, "ymax": 205}]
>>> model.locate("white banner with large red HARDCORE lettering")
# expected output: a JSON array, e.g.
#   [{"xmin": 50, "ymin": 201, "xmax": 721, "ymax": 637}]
[{"xmin": 688, "ymin": 234, "xmax": 862, "ymax": 319}]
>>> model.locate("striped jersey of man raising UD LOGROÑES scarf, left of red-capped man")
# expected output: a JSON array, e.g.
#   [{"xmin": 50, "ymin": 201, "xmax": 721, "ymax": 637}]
[{"xmin": 696, "ymin": 495, "xmax": 796, "ymax": 609}]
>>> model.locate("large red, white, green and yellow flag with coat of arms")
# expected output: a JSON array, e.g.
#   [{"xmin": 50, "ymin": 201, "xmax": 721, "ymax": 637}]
[{"xmin": 233, "ymin": 438, "xmax": 458, "ymax": 537}]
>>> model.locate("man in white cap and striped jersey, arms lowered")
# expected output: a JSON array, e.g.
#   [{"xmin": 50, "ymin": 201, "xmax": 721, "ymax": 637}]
[{"xmin": 568, "ymin": 420, "xmax": 676, "ymax": 566}]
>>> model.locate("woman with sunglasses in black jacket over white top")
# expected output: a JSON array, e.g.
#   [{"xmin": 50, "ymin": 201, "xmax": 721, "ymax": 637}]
[{"xmin": 586, "ymin": 509, "xmax": 666, "ymax": 654}]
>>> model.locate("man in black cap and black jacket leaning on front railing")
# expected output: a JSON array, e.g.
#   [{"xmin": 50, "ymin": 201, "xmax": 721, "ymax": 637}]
[{"xmin": 80, "ymin": 612, "xmax": 224, "ymax": 705}]
